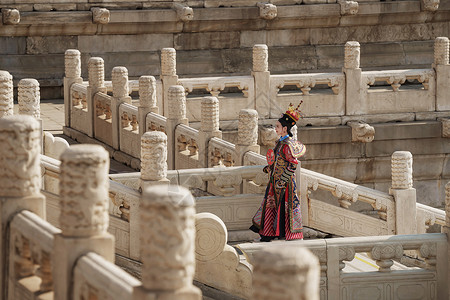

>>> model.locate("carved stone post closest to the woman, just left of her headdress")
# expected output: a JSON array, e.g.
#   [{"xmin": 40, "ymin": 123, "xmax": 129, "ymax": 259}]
[{"xmin": 236, "ymin": 109, "xmax": 259, "ymax": 166}]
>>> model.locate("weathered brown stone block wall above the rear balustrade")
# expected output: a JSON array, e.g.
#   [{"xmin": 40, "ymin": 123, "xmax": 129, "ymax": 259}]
[{"xmin": 0, "ymin": 0, "xmax": 450, "ymax": 99}]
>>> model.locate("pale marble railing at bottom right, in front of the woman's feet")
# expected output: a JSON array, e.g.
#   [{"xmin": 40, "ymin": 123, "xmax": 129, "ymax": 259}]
[{"xmin": 238, "ymin": 233, "xmax": 448, "ymax": 299}]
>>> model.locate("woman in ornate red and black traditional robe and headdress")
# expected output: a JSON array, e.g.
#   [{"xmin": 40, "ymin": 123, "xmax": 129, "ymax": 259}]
[{"xmin": 250, "ymin": 102, "xmax": 306, "ymax": 242}]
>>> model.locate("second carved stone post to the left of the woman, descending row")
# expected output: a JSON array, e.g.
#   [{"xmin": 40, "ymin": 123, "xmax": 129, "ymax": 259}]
[{"xmin": 198, "ymin": 97, "xmax": 222, "ymax": 168}]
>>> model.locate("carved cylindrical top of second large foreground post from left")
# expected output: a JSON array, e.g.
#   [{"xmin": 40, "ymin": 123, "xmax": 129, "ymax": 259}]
[{"xmin": 59, "ymin": 144, "xmax": 109, "ymax": 237}]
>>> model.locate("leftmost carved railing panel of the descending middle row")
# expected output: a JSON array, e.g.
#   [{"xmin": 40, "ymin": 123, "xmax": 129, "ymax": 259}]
[{"xmin": 69, "ymin": 83, "xmax": 90, "ymax": 134}]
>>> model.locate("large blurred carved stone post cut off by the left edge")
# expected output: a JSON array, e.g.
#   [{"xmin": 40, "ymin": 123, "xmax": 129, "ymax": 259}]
[{"xmin": 0, "ymin": 115, "xmax": 45, "ymax": 298}]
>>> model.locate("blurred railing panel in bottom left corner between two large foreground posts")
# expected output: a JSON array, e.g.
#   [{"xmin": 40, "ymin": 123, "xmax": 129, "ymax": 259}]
[{"xmin": 7, "ymin": 211, "xmax": 61, "ymax": 299}]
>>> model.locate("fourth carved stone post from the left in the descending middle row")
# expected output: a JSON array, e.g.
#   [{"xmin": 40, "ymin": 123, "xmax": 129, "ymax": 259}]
[{"xmin": 138, "ymin": 76, "xmax": 159, "ymax": 136}]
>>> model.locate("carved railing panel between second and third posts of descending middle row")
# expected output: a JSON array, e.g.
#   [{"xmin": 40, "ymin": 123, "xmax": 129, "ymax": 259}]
[{"xmin": 94, "ymin": 93, "xmax": 116, "ymax": 146}]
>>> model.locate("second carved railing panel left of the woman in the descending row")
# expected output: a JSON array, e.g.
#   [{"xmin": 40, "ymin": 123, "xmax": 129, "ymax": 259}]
[{"xmin": 175, "ymin": 124, "xmax": 200, "ymax": 170}]
